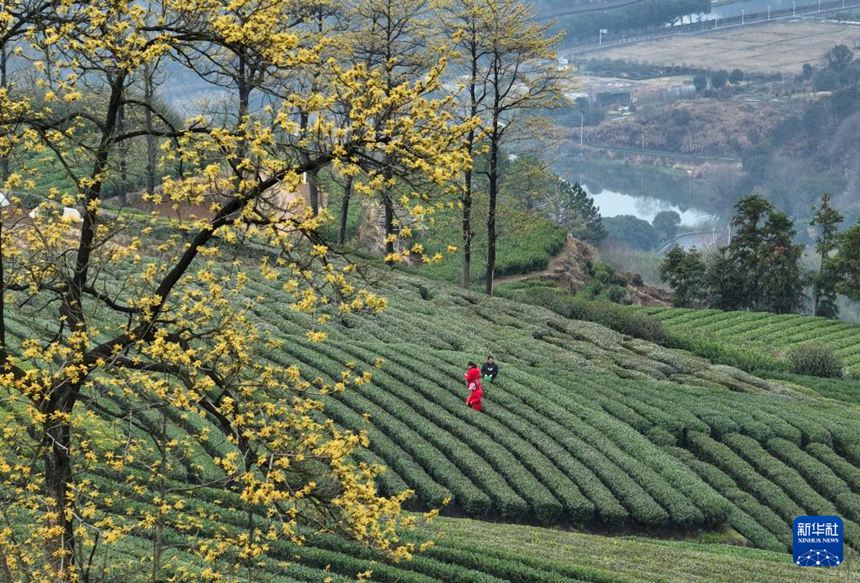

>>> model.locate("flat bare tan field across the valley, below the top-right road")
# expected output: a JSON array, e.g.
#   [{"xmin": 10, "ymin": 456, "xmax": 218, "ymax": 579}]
[{"xmin": 591, "ymin": 21, "xmax": 860, "ymax": 74}]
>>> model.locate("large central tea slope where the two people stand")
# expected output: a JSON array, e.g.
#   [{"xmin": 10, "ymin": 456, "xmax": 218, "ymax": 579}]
[{"xmin": 230, "ymin": 277, "xmax": 860, "ymax": 550}]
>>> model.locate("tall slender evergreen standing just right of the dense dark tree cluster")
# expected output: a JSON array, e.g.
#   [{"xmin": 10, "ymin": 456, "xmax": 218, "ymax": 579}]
[{"xmin": 809, "ymin": 194, "xmax": 843, "ymax": 318}]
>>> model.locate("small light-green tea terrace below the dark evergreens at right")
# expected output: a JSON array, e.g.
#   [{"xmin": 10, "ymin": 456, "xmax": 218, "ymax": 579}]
[{"xmin": 631, "ymin": 307, "xmax": 860, "ymax": 376}]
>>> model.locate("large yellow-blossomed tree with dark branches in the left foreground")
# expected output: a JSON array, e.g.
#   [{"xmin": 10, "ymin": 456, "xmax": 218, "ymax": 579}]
[{"xmin": 0, "ymin": 0, "xmax": 468, "ymax": 581}]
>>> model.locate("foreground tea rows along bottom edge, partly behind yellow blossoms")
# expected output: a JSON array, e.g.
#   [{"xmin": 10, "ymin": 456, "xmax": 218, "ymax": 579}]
[{"xmin": 52, "ymin": 466, "xmax": 840, "ymax": 583}]
